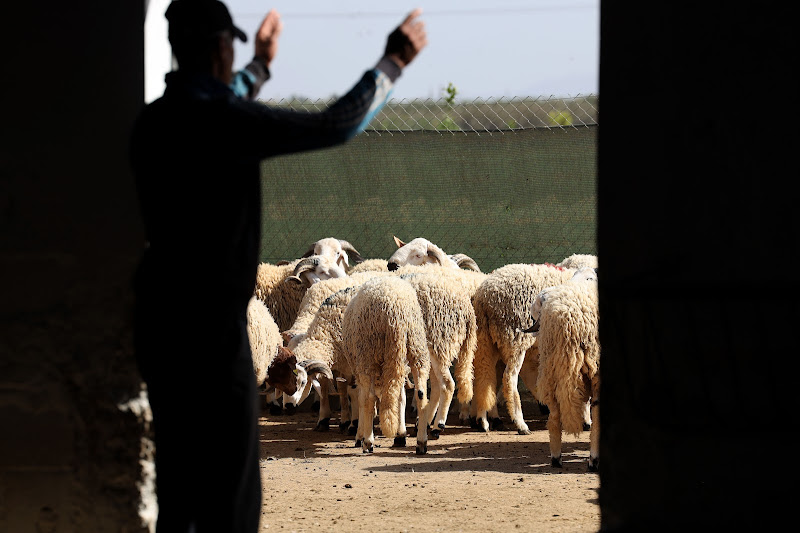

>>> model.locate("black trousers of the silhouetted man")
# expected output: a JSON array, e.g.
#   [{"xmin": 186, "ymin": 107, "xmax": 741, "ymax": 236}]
[{"xmin": 135, "ymin": 302, "xmax": 261, "ymax": 533}]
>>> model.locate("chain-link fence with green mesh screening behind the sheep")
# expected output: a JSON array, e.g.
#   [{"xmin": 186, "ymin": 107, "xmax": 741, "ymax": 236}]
[{"xmin": 255, "ymin": 95, "xmax": 598, "ymax": 272}]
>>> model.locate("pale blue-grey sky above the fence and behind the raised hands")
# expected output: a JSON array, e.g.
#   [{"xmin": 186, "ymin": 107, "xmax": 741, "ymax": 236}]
[{"xmin": 224, "ymin": 0, "xmax": 600, "ymax": 101}]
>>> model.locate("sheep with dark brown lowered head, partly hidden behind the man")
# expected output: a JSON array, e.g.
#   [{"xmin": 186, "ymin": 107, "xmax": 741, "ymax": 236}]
[{"xmin": 246, "ymin": 296, "xmax": 333, "ymax": 411}]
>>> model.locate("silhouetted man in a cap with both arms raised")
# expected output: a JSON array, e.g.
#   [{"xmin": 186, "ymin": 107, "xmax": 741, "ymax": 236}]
[{"xmin": 130, "ymin": 0, "xmax": 427, "ymax": 533}]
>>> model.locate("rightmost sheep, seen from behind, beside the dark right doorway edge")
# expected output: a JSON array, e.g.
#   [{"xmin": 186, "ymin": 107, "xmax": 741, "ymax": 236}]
[{"xmin": 535, "ymin": 276, "xmax": 600, "ymax": 471}]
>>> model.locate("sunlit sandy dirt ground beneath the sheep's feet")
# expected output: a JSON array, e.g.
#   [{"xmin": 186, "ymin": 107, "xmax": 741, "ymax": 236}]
[{"xmin": 260, "ymin": 392, "xmax": 600, "ymax": 533}]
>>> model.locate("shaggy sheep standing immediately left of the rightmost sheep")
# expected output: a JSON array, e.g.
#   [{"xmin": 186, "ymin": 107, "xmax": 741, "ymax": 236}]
[{"xmin": 471, "ymin": 263, "xmax": 574, "ymax": 434}]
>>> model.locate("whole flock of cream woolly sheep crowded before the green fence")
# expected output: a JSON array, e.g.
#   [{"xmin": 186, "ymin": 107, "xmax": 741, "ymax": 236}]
[{"xmin": 247, "ymin": 237, "xmax": 600, "ymax": 471}]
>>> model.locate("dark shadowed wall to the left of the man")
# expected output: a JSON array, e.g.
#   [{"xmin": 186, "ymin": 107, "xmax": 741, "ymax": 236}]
[{"xmin": 0, "ymin": 0, "xmax": 146, "ymax": 533}]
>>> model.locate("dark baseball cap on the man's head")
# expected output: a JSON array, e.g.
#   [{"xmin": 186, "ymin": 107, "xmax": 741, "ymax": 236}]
[{"xmin": 165, "ymin": 0, "xmax": 247, "ymax": 43}]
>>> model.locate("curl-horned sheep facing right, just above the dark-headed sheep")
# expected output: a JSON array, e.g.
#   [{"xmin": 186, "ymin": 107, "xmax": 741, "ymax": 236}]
[{"xmin": 253, "ymin": 256, "xmax": 346, "ymax": 331}]
